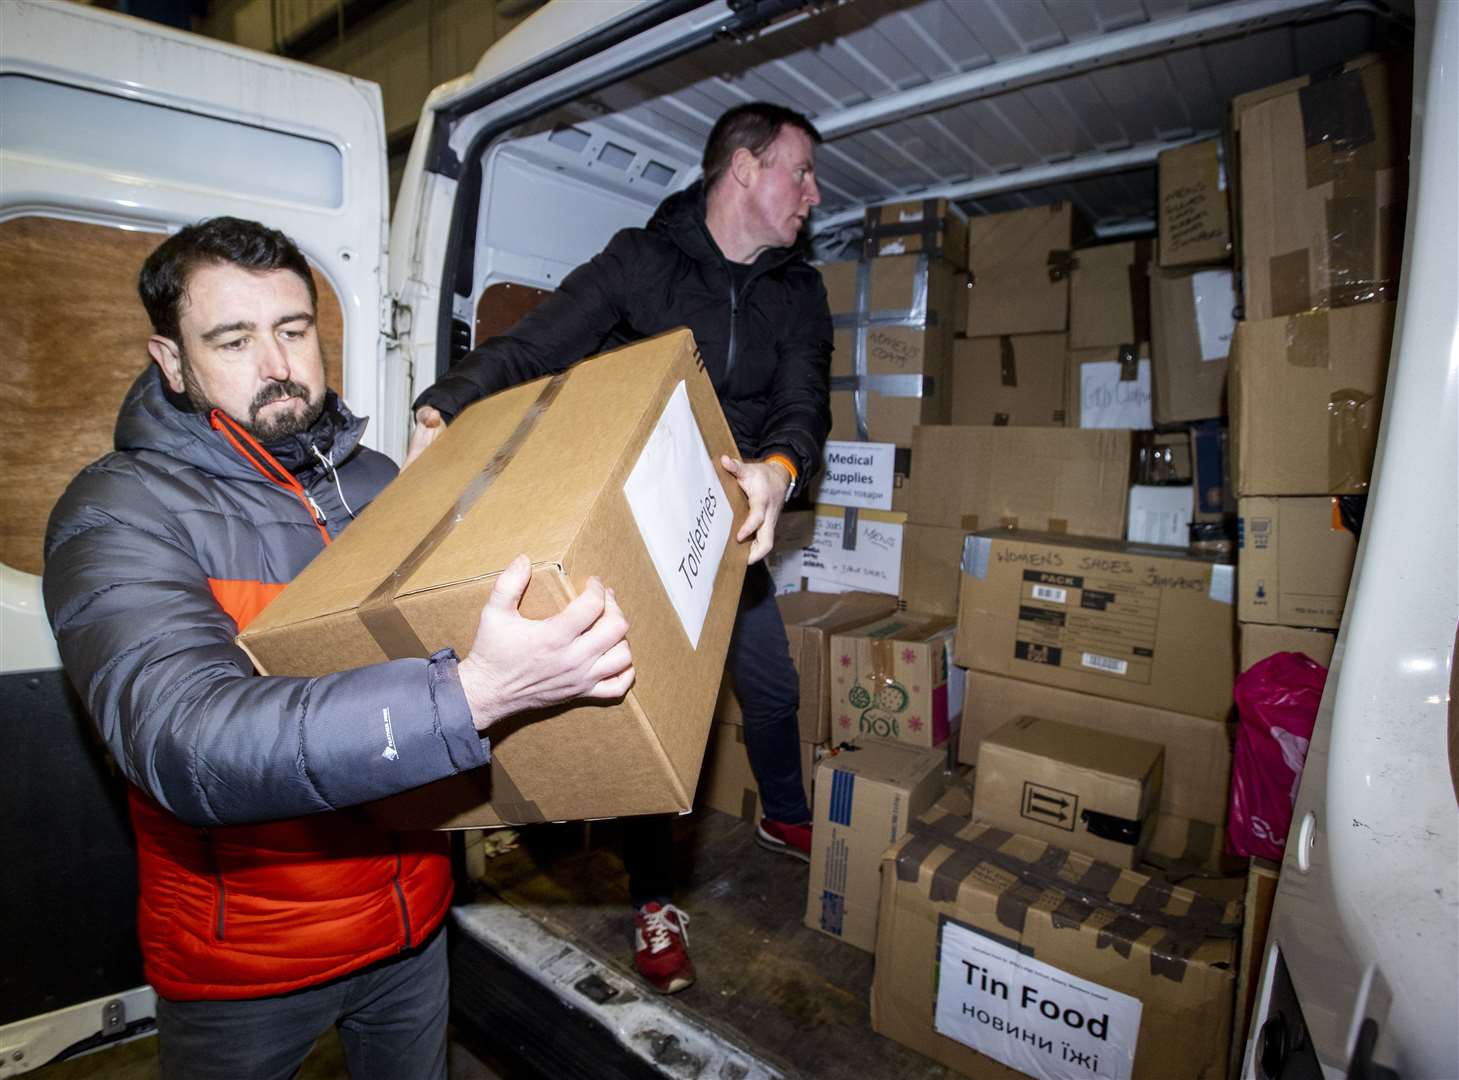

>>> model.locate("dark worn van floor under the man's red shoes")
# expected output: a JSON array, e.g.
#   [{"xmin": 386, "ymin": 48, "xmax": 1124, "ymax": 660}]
[{"xmin": 452, "ymin": 810, "xmax": 956, "ymax": 1080}]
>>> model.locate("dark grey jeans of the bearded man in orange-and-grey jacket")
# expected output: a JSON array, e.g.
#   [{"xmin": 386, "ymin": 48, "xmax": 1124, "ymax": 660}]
[{"xmin": 158, "ymin": 927, "xmax": 449, "ymax": 1080}]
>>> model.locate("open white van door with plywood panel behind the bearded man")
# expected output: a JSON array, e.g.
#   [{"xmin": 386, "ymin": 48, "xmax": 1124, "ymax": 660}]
[{"xmin": 0, "ymin": 0, "xmax": 388, "ymax": 1077}]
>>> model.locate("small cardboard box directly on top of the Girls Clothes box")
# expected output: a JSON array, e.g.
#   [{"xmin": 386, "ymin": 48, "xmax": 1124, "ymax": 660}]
[{"xmin": 1069, "ymin": 239, "xmax": 1151, "ymax": 349}]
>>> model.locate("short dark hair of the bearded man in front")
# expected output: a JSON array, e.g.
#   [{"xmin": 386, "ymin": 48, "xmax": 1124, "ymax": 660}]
[{"xmin": 137, "ymin": 217, "xmax": 320, "ymax": 344}]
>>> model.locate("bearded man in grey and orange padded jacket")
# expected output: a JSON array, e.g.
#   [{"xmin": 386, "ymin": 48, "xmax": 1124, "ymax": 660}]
[{"xmin": 44, "ymin": 217, "xmax": 633, "ymax": 1080}]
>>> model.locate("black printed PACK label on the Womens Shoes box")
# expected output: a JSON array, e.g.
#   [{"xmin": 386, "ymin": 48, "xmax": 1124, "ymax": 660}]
[{"xmin": 1014, "ymin": 569, "xmax": 1160, "ymax": 684}]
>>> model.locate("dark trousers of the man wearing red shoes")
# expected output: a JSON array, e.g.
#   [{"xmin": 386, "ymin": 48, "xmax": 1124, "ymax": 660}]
[{"xmin": 623, "ymin": 562, "xmax": 811, "ymax": 906}]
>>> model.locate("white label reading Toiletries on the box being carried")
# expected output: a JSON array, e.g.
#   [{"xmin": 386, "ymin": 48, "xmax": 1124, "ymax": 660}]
[{"xmin": 623, "ymin": 382, "xmax": 731, "ymax": 648}]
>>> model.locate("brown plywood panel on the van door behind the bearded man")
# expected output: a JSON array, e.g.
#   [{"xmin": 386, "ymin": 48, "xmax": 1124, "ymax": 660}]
[{"xmin": 0, "ymin": 217, "xmax": 344, "ymax": 574}]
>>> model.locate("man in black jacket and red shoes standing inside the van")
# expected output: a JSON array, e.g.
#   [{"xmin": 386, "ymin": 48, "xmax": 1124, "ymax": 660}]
[{"xmin": 407, "ymin": 102, "xmax": 832, "ymax": 992}]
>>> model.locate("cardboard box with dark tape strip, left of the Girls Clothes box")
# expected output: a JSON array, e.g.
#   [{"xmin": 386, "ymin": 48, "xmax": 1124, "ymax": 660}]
[{"xmin": 948, "ymin": 334, "xmax": 1068, "ymax": 428}]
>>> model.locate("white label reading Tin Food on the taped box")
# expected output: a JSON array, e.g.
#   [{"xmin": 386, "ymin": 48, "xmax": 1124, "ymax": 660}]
[{"xmin": 934, "ymin": 918, "xmax": 1142, "ymax": 1080}]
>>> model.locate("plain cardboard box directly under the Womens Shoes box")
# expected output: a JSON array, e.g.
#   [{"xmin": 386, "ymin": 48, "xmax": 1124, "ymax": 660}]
[{"xmin": 957, "ymin": 671, "xmax": 1231, "ymax": 823}]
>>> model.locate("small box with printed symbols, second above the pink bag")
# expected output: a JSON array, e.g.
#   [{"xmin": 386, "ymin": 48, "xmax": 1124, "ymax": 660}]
[{"xmin": 1236, "ymin": 496, "xmax": 1358, "ymax": 630}]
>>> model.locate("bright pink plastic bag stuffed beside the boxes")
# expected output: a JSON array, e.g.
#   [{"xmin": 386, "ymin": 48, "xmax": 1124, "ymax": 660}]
[{"xmin": 1226, "ymin": 652, "xmax": 1328, "ymax": 863}]
